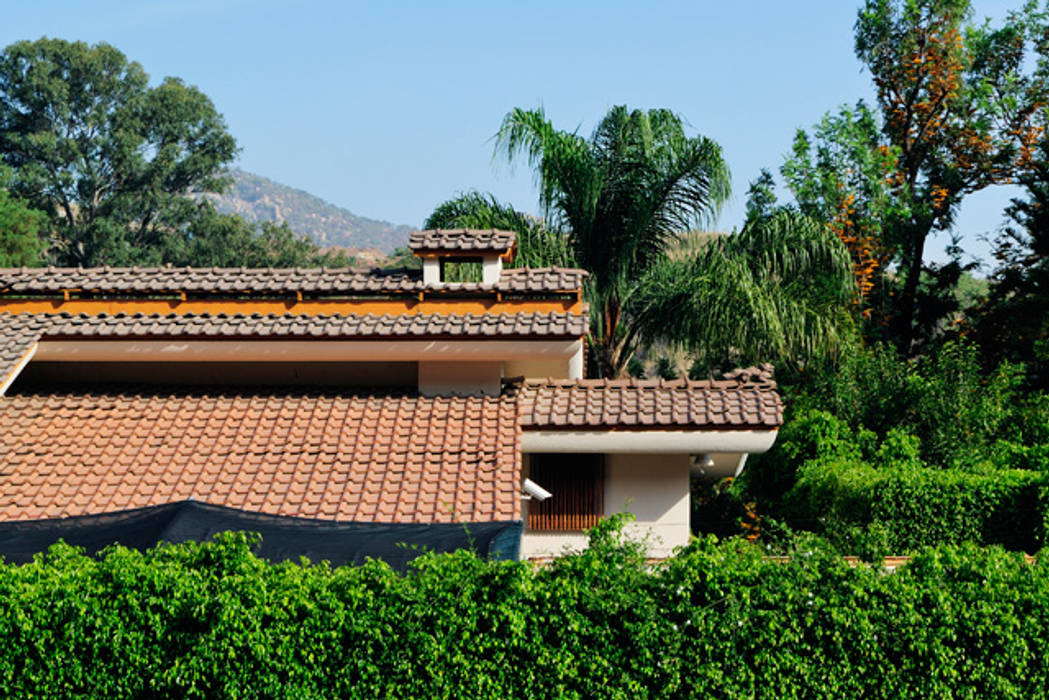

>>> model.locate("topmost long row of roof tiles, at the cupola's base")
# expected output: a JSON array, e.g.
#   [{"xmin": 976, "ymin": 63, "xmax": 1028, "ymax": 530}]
[{"xmin": 0, "ymin": 268, "xmax": 586, "ymax": 296}]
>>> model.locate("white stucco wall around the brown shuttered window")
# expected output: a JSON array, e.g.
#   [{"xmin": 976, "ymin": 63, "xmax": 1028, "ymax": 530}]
[{"xmin": 521, "ymin": 453, "xmax": 689, "ymax": 558}]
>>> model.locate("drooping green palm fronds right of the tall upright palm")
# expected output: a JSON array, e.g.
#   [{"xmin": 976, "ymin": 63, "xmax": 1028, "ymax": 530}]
[{"xmin": 629, "ymin": 210, "xmax": 855, "ymax": 375}]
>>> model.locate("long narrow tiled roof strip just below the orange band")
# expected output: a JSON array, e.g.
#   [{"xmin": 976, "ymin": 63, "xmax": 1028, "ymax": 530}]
[{"xmin": 0, "ymin": 312, "xmax": 587, "ymax": 384}]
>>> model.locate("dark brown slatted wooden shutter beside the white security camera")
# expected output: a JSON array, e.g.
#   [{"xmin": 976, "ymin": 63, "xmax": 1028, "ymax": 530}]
[{"xmin": 528, "ymin": 454, "xmax": 604, "ymax": 530}]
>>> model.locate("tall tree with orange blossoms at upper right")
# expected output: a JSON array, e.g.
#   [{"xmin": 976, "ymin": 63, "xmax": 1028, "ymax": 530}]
[{"xmin": 748, "ymin": 0, "xmax": 1049, "ymax": 354}]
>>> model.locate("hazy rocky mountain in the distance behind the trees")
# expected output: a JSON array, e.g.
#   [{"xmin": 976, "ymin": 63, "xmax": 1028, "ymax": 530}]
[{"xmin": 208, "ymin": 168, "xmax": 412, "ymax": 254}]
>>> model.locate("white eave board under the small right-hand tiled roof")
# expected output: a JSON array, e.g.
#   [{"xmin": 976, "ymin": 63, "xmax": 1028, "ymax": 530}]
[{"xmin": 521, "ymin": 430, "xmax": 776, "ymax": 454}]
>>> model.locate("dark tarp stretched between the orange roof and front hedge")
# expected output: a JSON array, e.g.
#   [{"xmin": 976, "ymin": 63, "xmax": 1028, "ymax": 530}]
[{"xmin": 0, "ymin": 501, "xmax": 522, "ymax": 571}]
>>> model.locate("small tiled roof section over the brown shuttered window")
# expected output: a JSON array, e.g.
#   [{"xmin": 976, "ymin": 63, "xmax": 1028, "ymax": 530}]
[{"xmin": 520, "ymin": 366, "xmax": 783, "ymax": 430}]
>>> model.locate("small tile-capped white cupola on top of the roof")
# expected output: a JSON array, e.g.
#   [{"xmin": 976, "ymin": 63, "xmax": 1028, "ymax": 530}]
[{"xmin": 408, "ymin": 229, "xmax": 516, "ymax": 285}]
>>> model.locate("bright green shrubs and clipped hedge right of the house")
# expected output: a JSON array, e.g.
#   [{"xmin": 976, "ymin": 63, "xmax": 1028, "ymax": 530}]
[{"xmin": 738, "ymin": 343, "xmax": 1049, "ymax": 553}]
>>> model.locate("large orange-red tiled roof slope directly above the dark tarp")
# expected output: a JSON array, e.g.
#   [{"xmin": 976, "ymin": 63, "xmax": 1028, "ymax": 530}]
[{"xmin": 0, "ymin": 386, "xmax": 520, "ymax": 523}]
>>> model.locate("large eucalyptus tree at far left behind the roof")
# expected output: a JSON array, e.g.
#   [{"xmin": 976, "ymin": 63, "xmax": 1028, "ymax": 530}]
[{"xmin": 0, "ymin": 38, "xmax": 236, "ymax": 264}]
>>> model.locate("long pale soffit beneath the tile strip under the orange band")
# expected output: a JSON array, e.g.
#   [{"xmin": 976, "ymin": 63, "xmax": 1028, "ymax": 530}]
[{"xmin": 36, "ymin": 339, "xmax": 582, "ymax": 362}]
